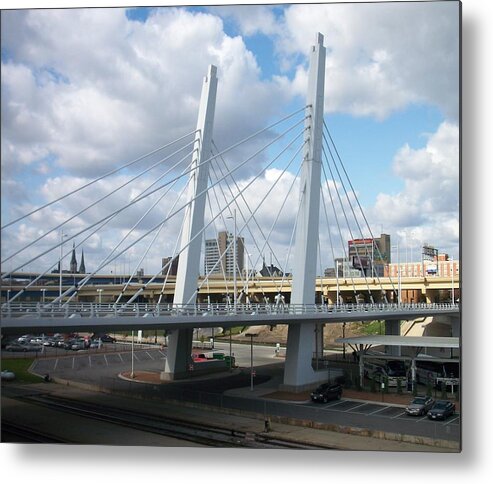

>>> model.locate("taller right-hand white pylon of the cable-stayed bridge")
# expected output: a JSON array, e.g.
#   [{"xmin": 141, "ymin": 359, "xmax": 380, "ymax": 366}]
[{"xmin": 283, "ymin": 33, "xmax": 326, "ymax": 391}]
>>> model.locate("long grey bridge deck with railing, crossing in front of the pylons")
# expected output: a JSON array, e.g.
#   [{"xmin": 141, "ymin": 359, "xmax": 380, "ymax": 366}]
[{"xmin": 2, "ymin": 303, "xmax": 459, "ymax": 334}]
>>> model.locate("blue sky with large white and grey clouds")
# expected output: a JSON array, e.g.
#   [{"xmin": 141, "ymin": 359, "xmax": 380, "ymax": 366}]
[{"xmin": 1, "ymin": 1, "xmax": 459, "ymax": 280}]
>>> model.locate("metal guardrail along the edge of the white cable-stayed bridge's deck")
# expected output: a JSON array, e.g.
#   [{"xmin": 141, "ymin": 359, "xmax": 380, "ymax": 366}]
[{"xmin": 1, "ymin": 302, "xmax": 459, "ymax": 318}]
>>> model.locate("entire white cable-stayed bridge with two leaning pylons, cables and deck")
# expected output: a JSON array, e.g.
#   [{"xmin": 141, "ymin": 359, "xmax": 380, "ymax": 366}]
[{"xmin": 1, "ymin": 34, "xmax": 459, "ymax": 389}]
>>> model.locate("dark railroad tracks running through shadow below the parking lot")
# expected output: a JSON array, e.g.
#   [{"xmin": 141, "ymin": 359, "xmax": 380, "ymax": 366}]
[{"xmin": 14, "ymin": 394, "xmax": 327, "ymax": 450}]
